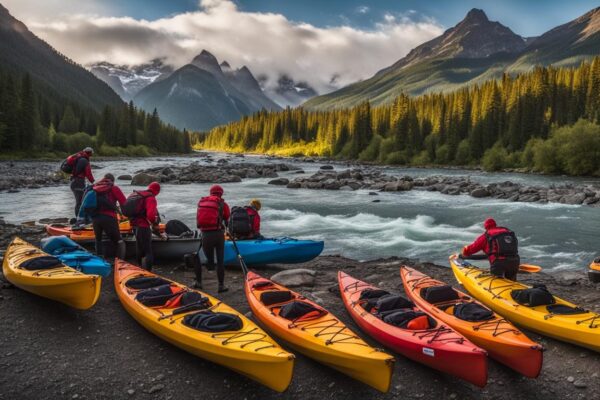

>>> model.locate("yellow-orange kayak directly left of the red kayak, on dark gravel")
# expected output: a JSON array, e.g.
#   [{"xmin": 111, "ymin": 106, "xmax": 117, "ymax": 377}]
[{"xmin": 245, "ymin": 272, "xmax": 394, "ymax": 392}]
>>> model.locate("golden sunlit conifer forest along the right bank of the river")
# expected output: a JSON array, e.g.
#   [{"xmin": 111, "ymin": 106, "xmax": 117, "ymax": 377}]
[{"xmin": 196, "ymin": 57, "xmax": 600, "ymax": 174}]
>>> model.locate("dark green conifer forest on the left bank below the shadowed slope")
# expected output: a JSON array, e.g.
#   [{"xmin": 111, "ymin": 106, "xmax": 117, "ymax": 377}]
[{"xmin": 0, "ymin": 70, "xmax": 191, "ymax": 155}]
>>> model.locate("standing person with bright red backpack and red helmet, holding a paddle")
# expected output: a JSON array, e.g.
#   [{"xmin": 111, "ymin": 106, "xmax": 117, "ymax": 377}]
[{"xmin": 199, "ymin": 185, "xmax": 230, "ymax": 293}]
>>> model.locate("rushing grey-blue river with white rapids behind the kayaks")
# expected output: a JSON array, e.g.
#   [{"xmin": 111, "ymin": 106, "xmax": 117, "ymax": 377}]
[{"xmin": 0, "ymin": 155, "xmax": 600, "ymax": 270}]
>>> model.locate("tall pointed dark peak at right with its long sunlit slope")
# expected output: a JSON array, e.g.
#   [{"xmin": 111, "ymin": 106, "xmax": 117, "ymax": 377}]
[{"xmin": 304, "ymin": 9, "xmax": 526, "ymax": 109}]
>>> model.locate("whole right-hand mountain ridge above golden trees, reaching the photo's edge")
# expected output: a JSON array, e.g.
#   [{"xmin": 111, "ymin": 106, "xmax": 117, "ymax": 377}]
[{"xmin": 303, "ymin": 8, "xmax": 600, "ymax": 109}]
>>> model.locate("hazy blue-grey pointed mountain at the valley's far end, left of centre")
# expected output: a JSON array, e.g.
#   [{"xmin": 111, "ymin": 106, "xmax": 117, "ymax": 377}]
[{"xmin": 134, "ymin": 50, "xmax": 281, "ymax": 131}]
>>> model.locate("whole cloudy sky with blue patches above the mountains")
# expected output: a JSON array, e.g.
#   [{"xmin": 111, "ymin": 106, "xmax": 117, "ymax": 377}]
[{"xmin": 0, "ymin": 0, "xmax": 597, "ymax": 92}]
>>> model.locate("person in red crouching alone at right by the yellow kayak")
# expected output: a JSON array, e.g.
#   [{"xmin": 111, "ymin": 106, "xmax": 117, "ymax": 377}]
[{"xmin": 461, "ymin": 218, "xmax": 521, "ymax": 281}]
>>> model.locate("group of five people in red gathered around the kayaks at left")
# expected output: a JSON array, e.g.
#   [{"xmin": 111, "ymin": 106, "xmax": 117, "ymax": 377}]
[{"xmin": 61, "ymin": 147, "xmax": 262, "ymax": 293}]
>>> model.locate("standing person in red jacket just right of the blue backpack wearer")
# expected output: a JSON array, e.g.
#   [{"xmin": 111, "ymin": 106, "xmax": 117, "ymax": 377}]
[{"xmin": 129, "ymin": 182, "xmax": 160, "ymax": 271}]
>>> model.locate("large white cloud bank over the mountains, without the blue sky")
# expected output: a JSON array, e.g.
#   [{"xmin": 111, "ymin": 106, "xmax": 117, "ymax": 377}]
[{"xmin": 7, "ymin": 0, "xmax": 443, "ymax": 93}]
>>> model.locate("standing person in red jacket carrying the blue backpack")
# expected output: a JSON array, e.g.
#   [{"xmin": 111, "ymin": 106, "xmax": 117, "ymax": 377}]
[{"xmin": 92, "ymin": 174, "xmax": 126, "ymax": 259}]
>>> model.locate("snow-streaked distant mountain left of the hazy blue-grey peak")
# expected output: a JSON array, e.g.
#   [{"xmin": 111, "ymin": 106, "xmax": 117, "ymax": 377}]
[{"xmin": 88, "ymin": 58, "xmax": 173, "ymax": 101}]
